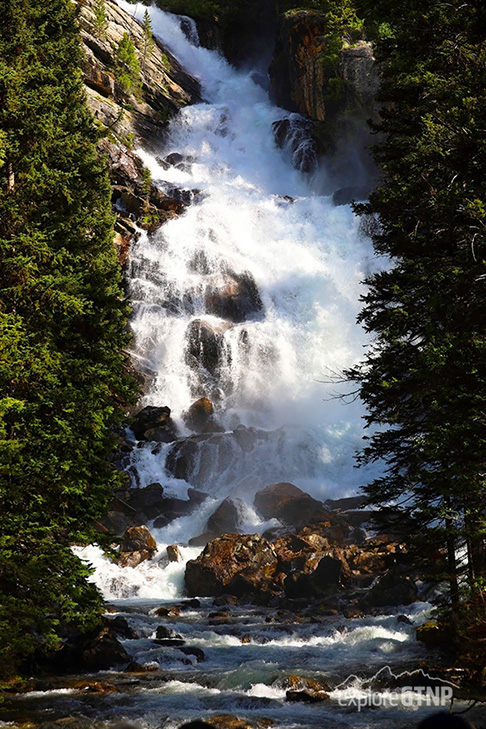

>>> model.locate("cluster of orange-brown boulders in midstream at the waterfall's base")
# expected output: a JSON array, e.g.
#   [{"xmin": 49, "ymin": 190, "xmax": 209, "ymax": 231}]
[{"xmin": 185, "ymin": 484, "xmax": 417, "ymax": 613}]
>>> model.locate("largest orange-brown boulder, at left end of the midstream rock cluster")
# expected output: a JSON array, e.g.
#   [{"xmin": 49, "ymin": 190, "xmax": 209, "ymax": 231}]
[{"xmin": 185, "ymin": 534, "xmax": 278, "ymax": 596}]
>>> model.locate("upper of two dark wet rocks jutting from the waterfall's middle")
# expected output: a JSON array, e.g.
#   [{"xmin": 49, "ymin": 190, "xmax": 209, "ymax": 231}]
[{"xmin": 204, "ymin": 271, "xmax": 263, "ymax": 323}]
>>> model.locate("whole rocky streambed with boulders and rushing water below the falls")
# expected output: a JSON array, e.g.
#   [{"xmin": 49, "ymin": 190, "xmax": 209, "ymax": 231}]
[{"xmin": 1, "ymin": 483, "xmax": 481, "ymax": 729}]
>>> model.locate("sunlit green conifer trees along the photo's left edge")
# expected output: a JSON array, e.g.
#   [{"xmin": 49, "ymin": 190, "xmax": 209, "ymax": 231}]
[{"xmin": 0, "ymin": 0, "xmax": 133, "ymax": 673}]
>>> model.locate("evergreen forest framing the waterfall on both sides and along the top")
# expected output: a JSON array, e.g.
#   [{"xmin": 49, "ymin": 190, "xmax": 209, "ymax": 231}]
[{"xmin": 0, "ymin": 0, "xmax": 486, "ymax": 692}]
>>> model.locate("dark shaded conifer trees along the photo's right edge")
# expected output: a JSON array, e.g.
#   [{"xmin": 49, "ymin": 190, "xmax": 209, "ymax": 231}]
[{"xmin": 350, "ymin": 0, "xmax": 486, "ymax": 613}]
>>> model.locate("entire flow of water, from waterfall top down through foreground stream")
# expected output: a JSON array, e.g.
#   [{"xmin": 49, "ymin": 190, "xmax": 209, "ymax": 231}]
[{"xmin": 0, "ymin": 0, "xmax": 481, "ymax": 729}]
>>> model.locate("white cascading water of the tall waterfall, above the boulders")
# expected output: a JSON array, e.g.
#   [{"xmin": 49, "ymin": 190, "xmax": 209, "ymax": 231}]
[{"xmin": 120, "ymin": 0, "xmax": 380, "ymax": 524}]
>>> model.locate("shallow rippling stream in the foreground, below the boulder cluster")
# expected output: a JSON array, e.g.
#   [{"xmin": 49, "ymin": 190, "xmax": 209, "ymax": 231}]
[{"xmin": 0, "ymin": 598, "xmax": 468, "ymax": 729}]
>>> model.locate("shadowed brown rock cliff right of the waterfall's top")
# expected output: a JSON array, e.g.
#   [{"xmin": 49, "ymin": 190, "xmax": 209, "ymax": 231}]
[{"xmin": 269, "ymin": 10, "xmax": 379, "ymax": 184}]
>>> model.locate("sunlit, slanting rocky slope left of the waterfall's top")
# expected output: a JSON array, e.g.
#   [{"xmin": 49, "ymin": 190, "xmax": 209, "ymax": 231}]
[{"xmin": 79, "ymin": 0, "xmax": 200, "ymax": 265}]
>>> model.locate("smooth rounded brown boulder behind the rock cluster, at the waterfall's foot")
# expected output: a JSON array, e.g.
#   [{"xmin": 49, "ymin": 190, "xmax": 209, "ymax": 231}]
[{"xmin": 253, "ymin": 483, "xmax": 330, "ymax": 526}]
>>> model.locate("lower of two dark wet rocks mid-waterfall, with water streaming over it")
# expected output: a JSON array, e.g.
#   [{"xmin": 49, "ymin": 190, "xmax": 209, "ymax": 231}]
[{"xmin": 186, "ymin": 319, "xmax": 231, "ymax": 376}]
